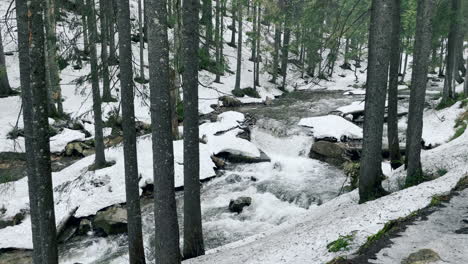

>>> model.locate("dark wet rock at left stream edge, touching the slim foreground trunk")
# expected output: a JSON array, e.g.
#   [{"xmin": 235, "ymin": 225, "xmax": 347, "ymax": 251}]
[{"xmin": 93, "ymin": 206, "xmax": 127, "ymax": 235}]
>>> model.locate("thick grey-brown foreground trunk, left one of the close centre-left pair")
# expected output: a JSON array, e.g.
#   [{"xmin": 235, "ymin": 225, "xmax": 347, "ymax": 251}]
[{"xmin": 145, "ymin": 0, "xmax": 182, "ymax": 264}]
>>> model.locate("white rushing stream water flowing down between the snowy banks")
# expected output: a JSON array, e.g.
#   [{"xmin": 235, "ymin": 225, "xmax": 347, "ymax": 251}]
[{"xmin": 60, "ymin": 91, "xmax": 363, "ymax": 263}]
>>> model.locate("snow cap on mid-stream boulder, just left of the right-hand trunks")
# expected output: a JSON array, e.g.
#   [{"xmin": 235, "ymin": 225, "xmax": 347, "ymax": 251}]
[{"xmin": 299, "ymin": 115, "xmax": 363, "ymax": 141}]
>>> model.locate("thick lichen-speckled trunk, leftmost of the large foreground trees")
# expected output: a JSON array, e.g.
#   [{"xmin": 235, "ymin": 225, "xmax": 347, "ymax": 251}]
[{"xmin": 17, "ymin": 0, "xmax": 58, "ymax": 264}]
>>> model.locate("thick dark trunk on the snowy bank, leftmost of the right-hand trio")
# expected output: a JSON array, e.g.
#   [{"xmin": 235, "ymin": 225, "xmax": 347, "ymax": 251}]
[{"xmin": 359, "ymin": 0, "xmax": 392, "ymax": 203}]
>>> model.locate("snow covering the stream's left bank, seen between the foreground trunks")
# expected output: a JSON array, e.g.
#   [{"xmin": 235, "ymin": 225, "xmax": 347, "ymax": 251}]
[{"xmin": 0, "ymin": 136, "xmax": 215, "ymax": 248}]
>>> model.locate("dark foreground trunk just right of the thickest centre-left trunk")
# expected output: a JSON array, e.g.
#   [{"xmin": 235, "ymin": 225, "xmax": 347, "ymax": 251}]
[{"xmin": 182, "ymin": 0, "xmax": 205, "ymax": 259}]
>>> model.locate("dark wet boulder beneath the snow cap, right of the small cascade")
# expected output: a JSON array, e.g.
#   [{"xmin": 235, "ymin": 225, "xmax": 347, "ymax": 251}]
[{"xmin": 309, "ymin": 141, "xmax": 350, "ymax": 166}]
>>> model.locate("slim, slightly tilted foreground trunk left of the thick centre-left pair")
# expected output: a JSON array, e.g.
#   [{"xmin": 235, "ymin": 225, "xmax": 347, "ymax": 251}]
[{"xmin": 117, "ymin": 0, "xmax": 145, "ymax": 264}]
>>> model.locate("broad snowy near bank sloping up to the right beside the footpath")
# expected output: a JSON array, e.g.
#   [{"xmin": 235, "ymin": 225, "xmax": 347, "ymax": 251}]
[{"xmin": 184, "ymin": 130, "xmax": 468, "ymax": 264}]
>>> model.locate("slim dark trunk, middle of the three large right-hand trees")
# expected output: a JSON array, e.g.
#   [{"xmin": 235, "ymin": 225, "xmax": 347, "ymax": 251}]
[{"xmin": 387, "ymin": 0, "xmax": 402, "ymax": 169}]
